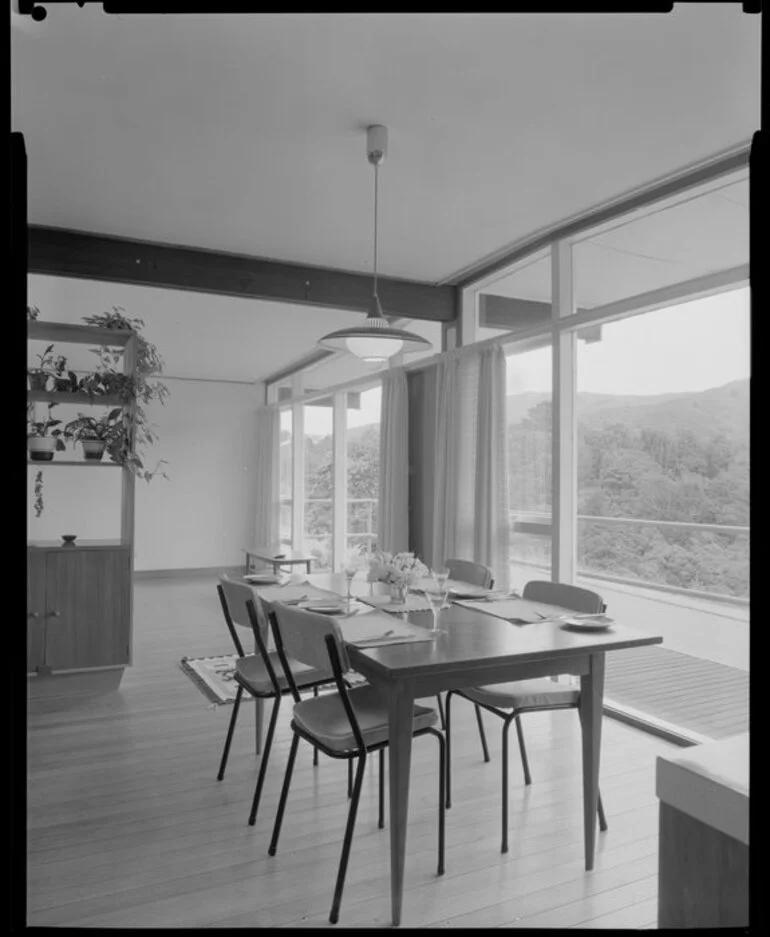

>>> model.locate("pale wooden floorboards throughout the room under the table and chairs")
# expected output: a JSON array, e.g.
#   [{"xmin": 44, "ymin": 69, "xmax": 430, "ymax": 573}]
[{"xmin": 27, "ymin": 579, "xmax": 675, "ymax": 928}]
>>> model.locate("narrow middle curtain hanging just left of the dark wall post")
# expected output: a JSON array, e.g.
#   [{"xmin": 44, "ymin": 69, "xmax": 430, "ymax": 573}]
[{"xmin": 377, "ymin": 368, "xmax": 409, "ymax": 553}]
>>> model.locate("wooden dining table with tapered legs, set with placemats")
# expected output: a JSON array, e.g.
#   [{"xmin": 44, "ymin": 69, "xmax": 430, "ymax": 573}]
[{"xmin": 256, "ymin": 573, "xmax": 663, "ymax": 925}]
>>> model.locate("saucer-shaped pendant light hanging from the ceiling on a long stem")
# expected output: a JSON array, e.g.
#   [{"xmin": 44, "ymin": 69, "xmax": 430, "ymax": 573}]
[{"xmin": 318, "ymin": 124, "xmax": 431, "ymax": 365}]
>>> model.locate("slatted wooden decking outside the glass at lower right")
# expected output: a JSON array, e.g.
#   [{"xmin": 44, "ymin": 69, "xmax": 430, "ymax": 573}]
[{"xmin": 605, "ymin": 647, "xmax": 749, "ymax": 739}]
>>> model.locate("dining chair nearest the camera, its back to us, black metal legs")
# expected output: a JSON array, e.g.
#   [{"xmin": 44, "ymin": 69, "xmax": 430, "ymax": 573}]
[{"xmin": 268, "ymin": 602, "xmax": 446, "ymax": 924}]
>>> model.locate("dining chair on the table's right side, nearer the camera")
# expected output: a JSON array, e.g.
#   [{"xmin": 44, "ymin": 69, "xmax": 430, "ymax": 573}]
[{"xmin": 445, "ymin": 580, "xmax": 607, "ymax": 852}]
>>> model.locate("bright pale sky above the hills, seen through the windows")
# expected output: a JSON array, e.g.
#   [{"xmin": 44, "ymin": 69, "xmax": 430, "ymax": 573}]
[{"xmin": 296, "ymin": 288, "xmax": 751, "ymax": 435}]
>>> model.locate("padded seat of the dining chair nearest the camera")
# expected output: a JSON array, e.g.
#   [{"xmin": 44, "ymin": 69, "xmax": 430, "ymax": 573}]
[{"xmin": 294, "ymin": 686, "xmax": 438, "ymax": 752}]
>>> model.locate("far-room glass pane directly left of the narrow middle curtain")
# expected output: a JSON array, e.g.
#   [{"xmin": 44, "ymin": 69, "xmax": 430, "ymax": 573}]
[{"xmin": 345, "ymin": 385, "xmax": 382, "ymax": 552}]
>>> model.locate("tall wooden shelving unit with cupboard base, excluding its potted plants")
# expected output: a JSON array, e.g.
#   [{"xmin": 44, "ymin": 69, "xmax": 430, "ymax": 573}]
[{"xmin": 27, "ymin": 321, "xmax": 136, "ymax": 675}]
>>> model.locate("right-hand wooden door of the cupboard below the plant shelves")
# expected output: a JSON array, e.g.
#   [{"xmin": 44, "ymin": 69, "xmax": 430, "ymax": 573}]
[{"xmin": 45, "ymin": 549, "xmax": 131, "ymax": 670}]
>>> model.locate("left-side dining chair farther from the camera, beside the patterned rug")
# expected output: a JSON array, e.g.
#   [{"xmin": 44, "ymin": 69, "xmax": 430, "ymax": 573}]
[{"xmin": 217, "ymin": 576, "xmax": 334, "ymax": 826}]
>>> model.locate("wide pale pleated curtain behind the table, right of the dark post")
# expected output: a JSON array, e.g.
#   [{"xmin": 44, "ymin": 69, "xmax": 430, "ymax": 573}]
[{"xmin": 432, "ymin": 345, "xmax": 509, "ymax": 589}]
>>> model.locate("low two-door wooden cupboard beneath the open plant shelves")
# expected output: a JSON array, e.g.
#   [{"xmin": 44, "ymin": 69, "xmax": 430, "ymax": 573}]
[{"xmin": 27, "ymin": 544, "xmax": 131, "ymax": 672}]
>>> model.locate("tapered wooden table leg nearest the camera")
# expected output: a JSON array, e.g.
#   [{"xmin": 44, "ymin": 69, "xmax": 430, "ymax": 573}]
[{"xmin": 388, "ymin": 680, "xmax": 414, "ymax": 926}]
